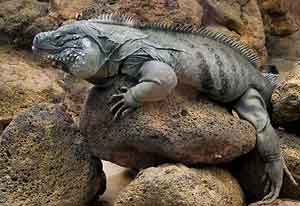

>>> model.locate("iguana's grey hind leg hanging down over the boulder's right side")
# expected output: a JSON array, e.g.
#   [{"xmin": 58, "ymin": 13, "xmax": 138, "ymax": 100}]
[{"xmin": 234, "ymin": 89, "xmax": 284, "ymax": 204}]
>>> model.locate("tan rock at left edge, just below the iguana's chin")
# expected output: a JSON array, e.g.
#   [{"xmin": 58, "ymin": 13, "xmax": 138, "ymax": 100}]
[{"xmin": 0, "ymin": 47, "xmax": 64, "ymax": 133}]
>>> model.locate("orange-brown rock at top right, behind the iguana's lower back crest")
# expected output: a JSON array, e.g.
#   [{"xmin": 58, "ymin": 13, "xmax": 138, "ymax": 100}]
[{"xmin": 200, "ymin": 0, "xmax": 267, "ymax": 63}]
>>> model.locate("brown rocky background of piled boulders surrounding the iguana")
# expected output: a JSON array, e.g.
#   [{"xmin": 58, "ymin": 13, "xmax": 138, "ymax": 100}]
[{"xmin": 0, "ymin": 0, "xmax": 300, "ymax": 206}]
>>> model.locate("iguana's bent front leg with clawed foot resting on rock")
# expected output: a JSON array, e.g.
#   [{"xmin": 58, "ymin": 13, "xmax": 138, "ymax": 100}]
[{"xmin": 110, "ymin": 61, "xmax": 177, "ymax": 120}]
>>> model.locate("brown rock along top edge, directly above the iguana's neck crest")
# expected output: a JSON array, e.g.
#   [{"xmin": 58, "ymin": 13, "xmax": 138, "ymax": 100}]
[{"xmin": 83, "ymin": 0, "xmax": 203, "ymax": 24}]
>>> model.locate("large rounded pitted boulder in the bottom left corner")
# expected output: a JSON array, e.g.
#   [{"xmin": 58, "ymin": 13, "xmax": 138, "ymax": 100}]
[{"xmin": 0, "ymin": 104, "xmax": 106, "ymax": 206}]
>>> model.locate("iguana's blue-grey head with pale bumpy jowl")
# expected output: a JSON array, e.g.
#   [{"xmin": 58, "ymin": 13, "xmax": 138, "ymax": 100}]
[{"xmin": 32, "ymin": 22, "xmax": 101, "ymax": 79}]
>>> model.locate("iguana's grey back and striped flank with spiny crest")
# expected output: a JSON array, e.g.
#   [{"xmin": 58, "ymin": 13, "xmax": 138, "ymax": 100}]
[{"xmin": 90, "ymin": 16, "xmax": 272, "ymax": 102}]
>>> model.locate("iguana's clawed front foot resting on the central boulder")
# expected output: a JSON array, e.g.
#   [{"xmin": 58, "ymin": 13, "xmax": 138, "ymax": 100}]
[{"xmin": 109, "ymin": 87, "xmax": 139, "ymax": 122}]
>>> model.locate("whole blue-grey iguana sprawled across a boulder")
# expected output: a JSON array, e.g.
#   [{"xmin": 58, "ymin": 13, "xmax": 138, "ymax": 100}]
[{"xmin": 32, "ymin": 15, "xmax": 298, "ymax": 203}]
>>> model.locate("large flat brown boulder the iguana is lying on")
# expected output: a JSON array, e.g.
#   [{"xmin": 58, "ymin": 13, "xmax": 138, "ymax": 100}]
[{"xmin": 80, "ymin": 79, "xmax": 256, "ymax": 168}]
